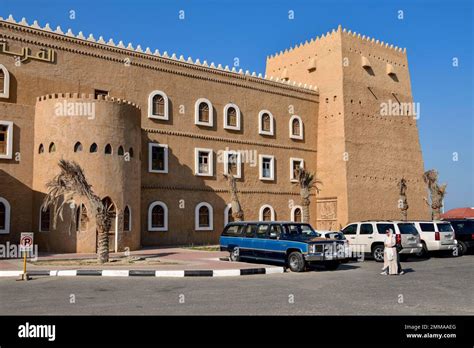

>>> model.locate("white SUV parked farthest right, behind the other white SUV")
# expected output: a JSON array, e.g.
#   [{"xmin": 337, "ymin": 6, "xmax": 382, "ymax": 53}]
[{"xmin": 412, "ymin": 221, "xmax": 457, "ymax": 257}]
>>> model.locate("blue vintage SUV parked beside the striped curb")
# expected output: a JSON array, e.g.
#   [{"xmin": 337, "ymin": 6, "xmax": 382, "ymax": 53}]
[{"xmin": 220, "ymin": 221, "xmax": 349, "ymax": 272}]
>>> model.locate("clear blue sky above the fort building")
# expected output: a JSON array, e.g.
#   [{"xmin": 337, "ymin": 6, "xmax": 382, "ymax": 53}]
[{"xmin": 0, "ymin": 0, "xmax": 474, "ymax": 209}]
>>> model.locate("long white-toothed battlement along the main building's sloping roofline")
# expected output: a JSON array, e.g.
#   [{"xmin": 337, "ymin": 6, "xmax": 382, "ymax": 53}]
[{"xmin": 0, "ymin": 14, "xmax": 318, "ymax": 94}]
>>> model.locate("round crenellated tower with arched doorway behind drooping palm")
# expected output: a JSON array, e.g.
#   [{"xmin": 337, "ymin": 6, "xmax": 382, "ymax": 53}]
[{"xmin": 33, "ymin": 93, "xmax": 141, "ymax": 253}]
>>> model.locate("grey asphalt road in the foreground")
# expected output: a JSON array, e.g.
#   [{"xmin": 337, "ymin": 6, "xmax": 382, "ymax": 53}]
[{"xmin": 0, "ymin": 255, "xmax": 474, "ymax": 315}]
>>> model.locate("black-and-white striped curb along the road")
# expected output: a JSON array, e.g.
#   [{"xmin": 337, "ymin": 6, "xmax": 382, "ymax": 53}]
[{"xmin": 0, "ymin": 267, "xmax": 285, "ymax": 278}]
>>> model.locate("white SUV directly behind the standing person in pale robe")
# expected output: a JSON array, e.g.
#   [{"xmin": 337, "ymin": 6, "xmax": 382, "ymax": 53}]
[{"xmin": 341, "ymin": 220, "xmax": 421, "ymax": 262}]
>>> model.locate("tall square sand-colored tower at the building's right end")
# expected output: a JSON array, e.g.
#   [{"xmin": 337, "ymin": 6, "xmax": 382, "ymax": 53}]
[{"xmin": 266, "ymin": 26, "xmax": 429, "ymax": 229}]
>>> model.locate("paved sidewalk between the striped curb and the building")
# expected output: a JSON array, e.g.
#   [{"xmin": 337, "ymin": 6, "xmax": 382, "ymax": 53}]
[{"xmin": 0, "ymin": 248, "xmax": 281, "ymax": 272}]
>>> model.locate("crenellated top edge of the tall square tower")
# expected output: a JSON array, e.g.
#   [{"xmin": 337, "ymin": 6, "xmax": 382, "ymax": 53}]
[{"xmin": 267, "ymin": 25, "xmax": 406, "ymax": 60}]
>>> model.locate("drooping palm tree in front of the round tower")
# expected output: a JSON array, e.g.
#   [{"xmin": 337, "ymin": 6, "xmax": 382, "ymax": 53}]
[{"xmin": 41, "ymin": 159, "xmax": 112, "ymax": 263}]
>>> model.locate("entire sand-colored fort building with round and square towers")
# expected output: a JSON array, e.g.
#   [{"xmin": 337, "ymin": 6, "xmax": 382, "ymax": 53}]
[{"xmin": 0, "ymin": 16, "xmax": 429, "ymax": 252}]
